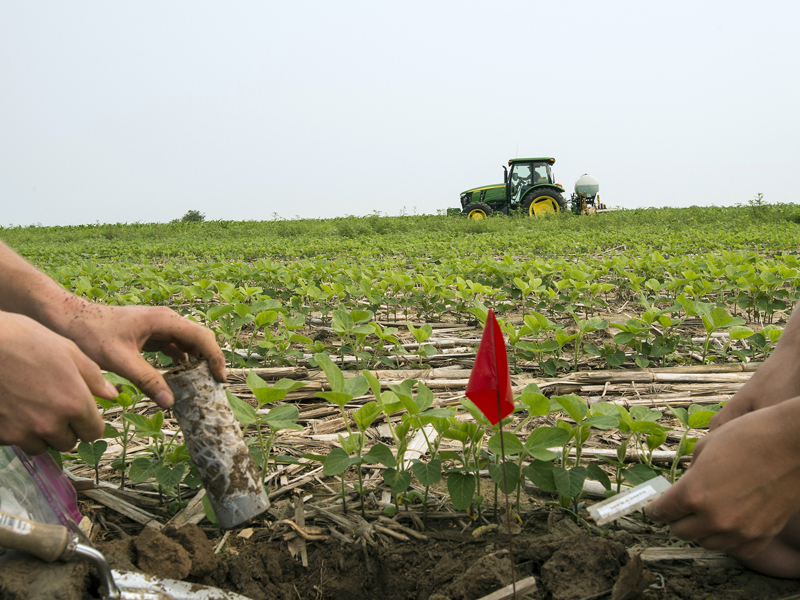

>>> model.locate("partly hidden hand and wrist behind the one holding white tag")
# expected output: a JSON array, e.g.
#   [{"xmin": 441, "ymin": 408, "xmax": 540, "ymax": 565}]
[{"xmin": 711, "ymin": 318, "xmax": 800, "ymax": 430}]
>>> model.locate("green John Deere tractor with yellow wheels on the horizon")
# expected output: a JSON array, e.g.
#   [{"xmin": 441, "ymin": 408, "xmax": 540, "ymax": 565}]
[{"xmin": 454, "ymin": 158, "xmax": 567, "ymax": 219}]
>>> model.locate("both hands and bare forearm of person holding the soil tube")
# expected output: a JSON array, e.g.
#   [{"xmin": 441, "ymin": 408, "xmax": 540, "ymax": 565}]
[{"xmin": 0, "ymin": 242, "xmax": 225, "ymax": 454}]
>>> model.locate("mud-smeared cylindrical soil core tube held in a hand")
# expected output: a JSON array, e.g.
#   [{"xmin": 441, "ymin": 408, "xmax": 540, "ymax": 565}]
[{"xmin": 164, "ymin": 361, "xmax": 269, "ymax": 529}]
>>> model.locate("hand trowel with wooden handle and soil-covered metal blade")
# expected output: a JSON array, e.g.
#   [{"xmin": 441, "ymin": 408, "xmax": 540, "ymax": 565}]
[{"xmin": 0, "ymin": 511, "xmax": 249, "ymax": 600}]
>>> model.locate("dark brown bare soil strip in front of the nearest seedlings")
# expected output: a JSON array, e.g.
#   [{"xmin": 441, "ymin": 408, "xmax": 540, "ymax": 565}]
[{"xmin": 0, "ymin": 509, "xmax": 800, "ymax": 600}]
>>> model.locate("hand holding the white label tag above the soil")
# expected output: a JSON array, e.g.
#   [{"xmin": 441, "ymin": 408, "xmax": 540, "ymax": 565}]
[{"xmin": 645, "ymin": 397, "xmax": 800, "ymax": 558}]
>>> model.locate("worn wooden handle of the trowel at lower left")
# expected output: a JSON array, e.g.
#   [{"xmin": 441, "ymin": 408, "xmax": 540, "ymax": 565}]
[{"xmin": 0, "ymin": 510, "xmax": 78, "ymax": 562}]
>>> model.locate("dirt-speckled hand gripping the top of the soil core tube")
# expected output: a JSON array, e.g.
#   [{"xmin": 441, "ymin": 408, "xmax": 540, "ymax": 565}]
[{"xmin": 60, "ymin": 302, "xmax": 225, "ymax": 408}]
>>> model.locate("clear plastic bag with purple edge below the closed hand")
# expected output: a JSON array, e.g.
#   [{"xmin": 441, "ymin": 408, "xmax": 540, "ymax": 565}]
[{"xmin": 0, "ymin": 446, "xmax": 81, "ymax": 527}]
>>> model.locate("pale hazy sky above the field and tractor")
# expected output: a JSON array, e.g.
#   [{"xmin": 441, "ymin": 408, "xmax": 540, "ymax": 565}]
[{"xmin": 0, "ymin": 0, "xmax": 800, "ymax": 226}]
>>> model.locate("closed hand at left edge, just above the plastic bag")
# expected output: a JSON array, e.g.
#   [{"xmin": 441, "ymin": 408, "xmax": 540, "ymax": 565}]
[{"xmin": 0, "ymin": 312, "xmax": 117, "ymax": 454}]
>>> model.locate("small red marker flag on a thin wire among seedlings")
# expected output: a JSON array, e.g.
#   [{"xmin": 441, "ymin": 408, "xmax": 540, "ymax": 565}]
[{"xmin": 467, "ymin": 308, "xmax": 514, "ymax": 425}]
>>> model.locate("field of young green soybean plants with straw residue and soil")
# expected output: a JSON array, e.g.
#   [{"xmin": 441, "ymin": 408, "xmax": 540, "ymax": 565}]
[{"xmin": 0, "ymin": 205, "xmax": 800, "ymax": 600}]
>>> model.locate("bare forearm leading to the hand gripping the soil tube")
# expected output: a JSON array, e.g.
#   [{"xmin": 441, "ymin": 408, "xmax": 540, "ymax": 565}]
[{"xmin": 0, "ymin": 242, "xmax": 89, "ymax": 333}]
